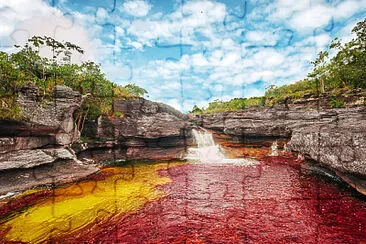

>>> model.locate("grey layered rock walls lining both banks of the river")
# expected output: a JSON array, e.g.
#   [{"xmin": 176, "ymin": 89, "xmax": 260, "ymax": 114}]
[{"xmin": 0, "ymin": 86, "xmax": 366, "ymax": 194}]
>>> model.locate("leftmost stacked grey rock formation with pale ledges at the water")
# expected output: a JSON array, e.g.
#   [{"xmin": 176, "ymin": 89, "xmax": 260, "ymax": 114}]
[{"xmin": 0, "ymin": 85, "xmax": 97, "ymax": 194}]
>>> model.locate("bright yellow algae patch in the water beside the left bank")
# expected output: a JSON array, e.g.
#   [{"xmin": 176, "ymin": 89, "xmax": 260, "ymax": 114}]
[{"xmin": 0, "ymin": 163, "xmax": 181, "ymax": 243}]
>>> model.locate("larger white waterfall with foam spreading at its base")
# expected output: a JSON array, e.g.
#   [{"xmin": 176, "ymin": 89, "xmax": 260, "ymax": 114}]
[{"xmin": 186, "ymin": 129, "xmax": 258, "ymax": 165}]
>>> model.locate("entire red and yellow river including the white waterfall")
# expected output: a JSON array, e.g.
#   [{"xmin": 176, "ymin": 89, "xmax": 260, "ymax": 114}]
[{"xmin": 0, "ymin": 130, "xmax": 366, "ymax": 243}]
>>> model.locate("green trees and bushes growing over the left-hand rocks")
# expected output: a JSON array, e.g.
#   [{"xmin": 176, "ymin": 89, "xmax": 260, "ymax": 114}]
[{"xmin": 0, "ymin": 36, "xmax": 147, "ymax": 127}]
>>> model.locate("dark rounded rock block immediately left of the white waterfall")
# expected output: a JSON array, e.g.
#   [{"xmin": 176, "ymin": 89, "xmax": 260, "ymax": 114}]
[{"xmin": 79, "ymin": 98, "xmax": 189, "ymax": 162}]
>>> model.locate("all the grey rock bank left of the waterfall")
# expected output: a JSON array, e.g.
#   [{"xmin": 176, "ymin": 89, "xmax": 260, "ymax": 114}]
[{"xmin": 0, "ymin": 85, "xmax": 189, "ymax": 195}]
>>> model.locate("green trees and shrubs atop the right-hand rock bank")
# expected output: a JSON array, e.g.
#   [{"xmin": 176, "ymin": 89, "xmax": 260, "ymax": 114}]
[{"xmin": 191, "ymin": 19, "xmax": 366, "ymax": 114}]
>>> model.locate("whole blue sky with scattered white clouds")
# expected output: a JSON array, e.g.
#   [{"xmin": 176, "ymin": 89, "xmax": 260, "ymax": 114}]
[{"xmin": 0, "ymin": 0, "xmax": 366, "ymax": 112}]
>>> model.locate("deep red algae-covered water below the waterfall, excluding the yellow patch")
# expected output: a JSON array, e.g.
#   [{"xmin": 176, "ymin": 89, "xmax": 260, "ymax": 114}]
[{"xmin": 55, "ymin": 156, "xmax": 366, "ymax": 243}]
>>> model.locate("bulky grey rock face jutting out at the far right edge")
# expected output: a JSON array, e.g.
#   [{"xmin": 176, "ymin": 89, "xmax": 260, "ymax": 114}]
[{"xmin": 289, "ymin": 109, "xmax": 366, "ymax": 176}]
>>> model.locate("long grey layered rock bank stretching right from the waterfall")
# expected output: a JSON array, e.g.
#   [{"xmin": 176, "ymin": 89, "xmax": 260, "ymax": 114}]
[{"xmin": 200, "ymin": 107, "xmax": 366, "ymax": 193}]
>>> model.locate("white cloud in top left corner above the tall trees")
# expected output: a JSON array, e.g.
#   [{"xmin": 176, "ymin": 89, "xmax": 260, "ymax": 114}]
[{"xmin": 0, "ymin": 0, "xmax": 99, "ymax": 62}]
